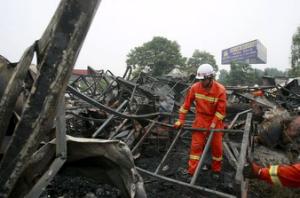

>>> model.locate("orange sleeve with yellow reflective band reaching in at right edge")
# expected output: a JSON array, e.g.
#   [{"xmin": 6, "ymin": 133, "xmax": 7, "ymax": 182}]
[{"xmin": 258, "ymin": 163, "xmax": 300, "ymax": 188}]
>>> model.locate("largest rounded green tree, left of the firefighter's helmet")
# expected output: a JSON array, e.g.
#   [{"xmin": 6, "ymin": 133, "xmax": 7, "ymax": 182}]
[{"xmin": 126, "ymin": 37, "xmax": 185, "ymax": 76}]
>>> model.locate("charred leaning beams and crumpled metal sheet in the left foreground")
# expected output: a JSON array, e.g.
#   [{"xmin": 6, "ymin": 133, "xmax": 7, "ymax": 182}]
[{"xmin": 0, "ymin": 0, "xmax": 145, "ymax": 197}]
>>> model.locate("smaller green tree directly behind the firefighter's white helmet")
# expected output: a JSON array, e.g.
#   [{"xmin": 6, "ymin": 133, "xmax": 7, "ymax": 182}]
[{"xmin": 184, "ymin": 49, "xmax": 218, "ymax": 74}]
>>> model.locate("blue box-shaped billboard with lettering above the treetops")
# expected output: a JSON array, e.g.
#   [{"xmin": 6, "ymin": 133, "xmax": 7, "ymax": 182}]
[{"xmin": 222, "ymin": 40, "xmax": 267, "ymax": 64}]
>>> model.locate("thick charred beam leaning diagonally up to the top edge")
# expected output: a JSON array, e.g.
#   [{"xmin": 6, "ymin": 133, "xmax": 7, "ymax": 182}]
[{"xmin": 0, "ymin": 0, "xmax": 101, "ymax": 197}]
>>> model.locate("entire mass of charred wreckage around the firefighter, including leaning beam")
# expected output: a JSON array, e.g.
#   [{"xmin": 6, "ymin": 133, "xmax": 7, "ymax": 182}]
[{"xmin": 0, "ymin": 0, "xmax": 300, "ymax": 198}]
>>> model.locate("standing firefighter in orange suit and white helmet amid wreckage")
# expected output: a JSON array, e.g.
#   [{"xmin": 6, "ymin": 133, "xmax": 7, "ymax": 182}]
[{"xmin": 174, "ymin": 64, "xmax": 226, "ymax": 178}]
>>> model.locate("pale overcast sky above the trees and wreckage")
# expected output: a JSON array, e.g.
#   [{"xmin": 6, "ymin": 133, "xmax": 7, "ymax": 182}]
[{"xmin": 0, "ymin": 0, "xmax": 300, "ymax": 75}]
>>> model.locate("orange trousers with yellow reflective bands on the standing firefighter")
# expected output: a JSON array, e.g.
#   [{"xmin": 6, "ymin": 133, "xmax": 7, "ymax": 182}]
[{"xmin": 188, "ymin": 131, "xmax": 223, "ymax": 175}]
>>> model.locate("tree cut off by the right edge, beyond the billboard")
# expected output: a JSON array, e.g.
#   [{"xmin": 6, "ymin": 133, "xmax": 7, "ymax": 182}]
[{"xmin": 289, "ymin": 27, "xmax": 300, "ymax": 77}]
